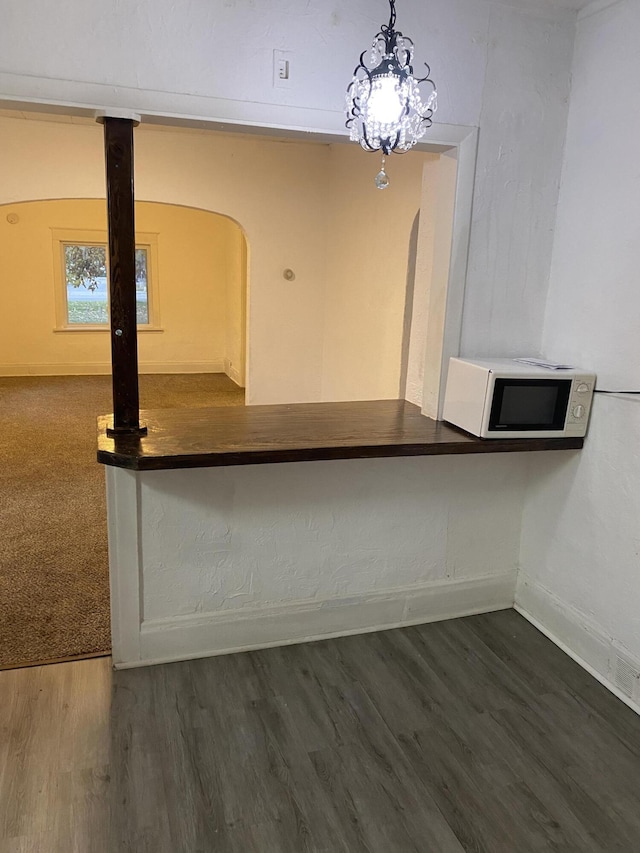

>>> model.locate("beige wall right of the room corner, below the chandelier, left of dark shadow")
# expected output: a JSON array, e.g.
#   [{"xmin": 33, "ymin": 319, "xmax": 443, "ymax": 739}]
[{"xmin": 322, "ymin": 145, "xmax": 439, "ymax": 400}]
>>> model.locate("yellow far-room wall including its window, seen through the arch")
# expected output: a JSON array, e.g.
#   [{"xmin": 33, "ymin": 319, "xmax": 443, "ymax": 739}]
[{"xmin": 0, "ymin": 199, "xmax": 247, "ymax": 386}]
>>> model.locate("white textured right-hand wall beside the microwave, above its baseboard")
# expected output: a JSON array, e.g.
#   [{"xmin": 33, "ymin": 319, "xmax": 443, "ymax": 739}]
[{"xmin": 522, "ymin": 5, "xmax": 640, "ymax": 666}]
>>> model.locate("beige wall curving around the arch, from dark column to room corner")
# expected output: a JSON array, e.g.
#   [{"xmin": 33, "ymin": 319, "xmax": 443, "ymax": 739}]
[{"xmin": 135, "ymin": 126, "xmax": 329, "ymax": 403}]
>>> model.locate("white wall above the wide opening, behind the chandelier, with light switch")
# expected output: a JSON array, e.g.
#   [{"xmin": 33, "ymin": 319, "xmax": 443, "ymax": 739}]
[{"xmin": 0, "ymin": 0, "xmax": 488, "ymax": 124}]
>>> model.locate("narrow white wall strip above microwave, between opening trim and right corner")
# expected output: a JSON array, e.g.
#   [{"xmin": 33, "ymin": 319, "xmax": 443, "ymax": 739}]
[{"xmin": 462, "ymin": 4, "xmax": 573, "ymax": 356}]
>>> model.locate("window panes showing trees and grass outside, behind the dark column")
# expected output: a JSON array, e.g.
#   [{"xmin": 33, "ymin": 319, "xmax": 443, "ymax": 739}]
[{"xmin": 64, "ymin": 243, "xmax": 149, "ymax": 326}]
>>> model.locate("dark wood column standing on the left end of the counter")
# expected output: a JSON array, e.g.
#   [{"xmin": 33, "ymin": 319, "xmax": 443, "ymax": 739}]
[{"xmin": 101, "ymin": 116, "xmax": 146, "ymax": 435}]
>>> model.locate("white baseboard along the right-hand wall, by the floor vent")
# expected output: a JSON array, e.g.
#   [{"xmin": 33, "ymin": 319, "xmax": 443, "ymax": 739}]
[{"xmin": 514, "ymin": 572, "xmax": 640, "ymax": 714}]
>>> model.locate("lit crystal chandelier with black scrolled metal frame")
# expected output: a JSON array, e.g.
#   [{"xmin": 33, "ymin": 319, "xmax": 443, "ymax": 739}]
[{"xmin": 346, "ymin": 0, "xmax": 436, "ymax": 189}]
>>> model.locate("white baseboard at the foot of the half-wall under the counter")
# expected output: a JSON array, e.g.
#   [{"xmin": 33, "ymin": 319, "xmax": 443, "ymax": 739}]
[{"xmin": 114, "ymin": 572, "xmax": 515, "ymax": 669}]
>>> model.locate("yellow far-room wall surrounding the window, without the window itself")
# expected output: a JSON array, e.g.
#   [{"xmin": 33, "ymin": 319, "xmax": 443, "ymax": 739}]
[{"xmin": 0, "ymin": 199, "xmax": 244, "ymax": 375}]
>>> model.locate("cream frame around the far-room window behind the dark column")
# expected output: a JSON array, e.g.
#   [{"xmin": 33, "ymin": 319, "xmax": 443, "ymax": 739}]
[{"xmin": 51, "ymin": 228, "xmax": 164, "ymax": 332}]
